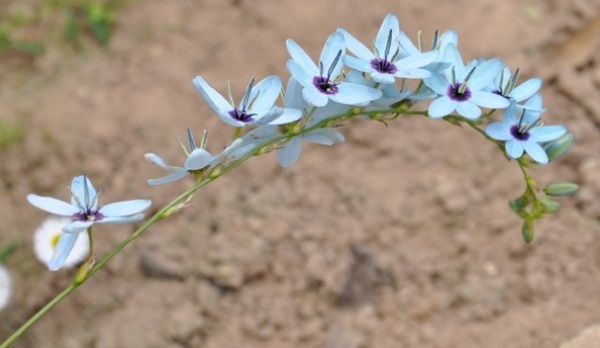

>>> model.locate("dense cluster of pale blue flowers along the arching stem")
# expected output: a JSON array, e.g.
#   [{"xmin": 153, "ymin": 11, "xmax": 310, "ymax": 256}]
[{"xmin": 146, "ymin": 14, "xmax": 567, "ymax": 185}]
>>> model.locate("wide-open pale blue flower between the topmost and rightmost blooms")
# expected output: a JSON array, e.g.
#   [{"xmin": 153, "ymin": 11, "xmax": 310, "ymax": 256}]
[{"xmin": 423, "ymin": 44, "xmax": 510, "ymax": 120}]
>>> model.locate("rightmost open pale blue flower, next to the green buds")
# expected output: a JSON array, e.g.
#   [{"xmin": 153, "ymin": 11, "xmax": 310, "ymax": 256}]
[{"xmin": 485, "ymin": 103, "xmax": 567, "ymax": 164}]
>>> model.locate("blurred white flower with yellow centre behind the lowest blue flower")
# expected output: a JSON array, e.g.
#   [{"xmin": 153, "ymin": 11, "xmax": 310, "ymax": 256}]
[{"xmin": 33, "ymin": 216, "xmax": 90, "ymax": 267}]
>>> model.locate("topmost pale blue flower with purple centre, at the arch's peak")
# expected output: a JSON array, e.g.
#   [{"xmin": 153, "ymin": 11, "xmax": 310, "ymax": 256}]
[{"xmin": 337, "ymin": 14, "xmax": 438, "ymax": 84}]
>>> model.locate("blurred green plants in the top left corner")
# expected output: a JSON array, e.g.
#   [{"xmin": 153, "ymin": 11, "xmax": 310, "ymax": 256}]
[{"xmin": 0, "ymin": 0, "xmax": 126, "ymax": 56}]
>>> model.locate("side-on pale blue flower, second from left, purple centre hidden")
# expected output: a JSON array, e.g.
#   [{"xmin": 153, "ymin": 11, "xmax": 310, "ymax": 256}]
[{"xmin": 144, "ymin": 129, "xmax": 252, "ymax": 186}]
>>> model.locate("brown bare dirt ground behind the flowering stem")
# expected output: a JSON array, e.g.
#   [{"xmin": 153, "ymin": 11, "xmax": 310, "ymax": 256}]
[{"xmin": 0, "ymin": 0, "xmax": 600, "ymax": 348}]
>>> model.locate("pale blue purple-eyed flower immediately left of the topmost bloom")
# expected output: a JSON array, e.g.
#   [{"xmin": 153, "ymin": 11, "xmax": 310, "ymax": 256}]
[{"xmin": 286, "ymin": 33, "xmax": 381, "ymax": 107}]
